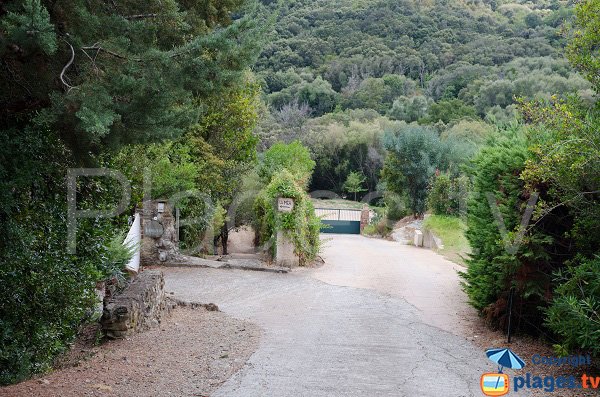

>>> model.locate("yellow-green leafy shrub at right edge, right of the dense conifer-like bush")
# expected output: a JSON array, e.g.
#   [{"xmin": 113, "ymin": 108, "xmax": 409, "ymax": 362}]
[{"xmin": 522, "ymin": 88, "xmax": 600, "ymax": 355}]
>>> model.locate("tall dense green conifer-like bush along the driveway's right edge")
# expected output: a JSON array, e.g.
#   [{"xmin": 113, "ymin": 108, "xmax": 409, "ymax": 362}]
[{"xmin": 462, "ymin": 129, "xmax": 552, "ymax": 326}]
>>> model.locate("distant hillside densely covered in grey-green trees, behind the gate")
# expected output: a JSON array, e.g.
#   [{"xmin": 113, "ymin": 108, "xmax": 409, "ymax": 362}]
[{"xmin": 257, "ymin": 0, "xmax": 588, "ymax": 115}]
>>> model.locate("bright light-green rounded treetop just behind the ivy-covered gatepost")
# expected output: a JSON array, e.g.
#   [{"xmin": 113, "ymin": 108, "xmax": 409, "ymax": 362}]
[{"xmin": 258, "ymin": 141, "xmax": 315, "ymax": 187}]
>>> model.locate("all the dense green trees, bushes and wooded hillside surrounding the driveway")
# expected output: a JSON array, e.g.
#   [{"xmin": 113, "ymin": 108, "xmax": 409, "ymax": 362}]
[{"xmin": 0, "ymin": 0, "xmax": 600, "ymax": 384}]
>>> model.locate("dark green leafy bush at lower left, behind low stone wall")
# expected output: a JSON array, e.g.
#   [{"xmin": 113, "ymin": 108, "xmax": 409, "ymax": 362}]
[{"xmin": 0, "ymin": 204, "xmax": 128, "ymax": 384}]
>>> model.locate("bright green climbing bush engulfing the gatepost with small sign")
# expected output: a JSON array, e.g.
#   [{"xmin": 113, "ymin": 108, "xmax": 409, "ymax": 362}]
[{"xmin": 254, "ymin": 169, "xmax": 321, "ymax": 265}]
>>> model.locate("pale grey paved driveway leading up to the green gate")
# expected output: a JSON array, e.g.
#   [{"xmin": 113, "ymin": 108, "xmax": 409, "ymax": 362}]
[{"xmin": 166, "ymin": 235, "xmax": 502, "ymax": 397}]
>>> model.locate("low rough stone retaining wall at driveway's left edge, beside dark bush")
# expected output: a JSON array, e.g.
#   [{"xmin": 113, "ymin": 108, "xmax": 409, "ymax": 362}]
[{"xmin": 100, "ymin": 270, "xmax": 171, "ymax": 338}]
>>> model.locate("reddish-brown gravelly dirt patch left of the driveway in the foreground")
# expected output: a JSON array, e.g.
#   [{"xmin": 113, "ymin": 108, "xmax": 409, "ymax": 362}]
[{"xmin": 0, "ymin": 307, "xmax": 261, "ymax": 397}]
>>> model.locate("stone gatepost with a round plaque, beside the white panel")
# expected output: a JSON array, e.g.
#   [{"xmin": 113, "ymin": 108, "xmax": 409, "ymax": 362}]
[{"xmin": 142, "ymin": 200, "xmax": 179, "ymax": 265}]
